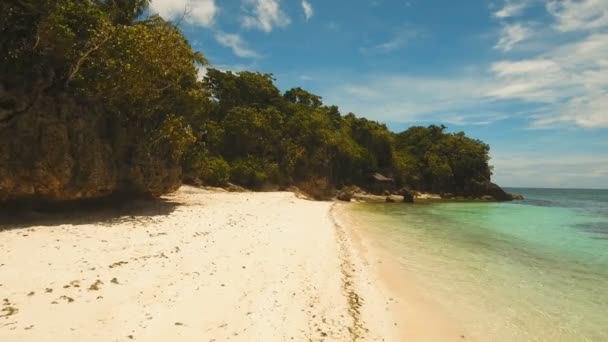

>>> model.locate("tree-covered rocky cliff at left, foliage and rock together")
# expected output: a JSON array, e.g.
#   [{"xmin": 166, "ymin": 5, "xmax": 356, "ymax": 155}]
[{"xmin": 0, "ymin": 0, "xmax": 208, "ymax": 200}]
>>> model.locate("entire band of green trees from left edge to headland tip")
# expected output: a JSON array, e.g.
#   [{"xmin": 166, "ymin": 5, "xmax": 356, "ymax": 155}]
[{"xmin": 0, "ymin": 0, "xmax": 498, "ymax": 199}]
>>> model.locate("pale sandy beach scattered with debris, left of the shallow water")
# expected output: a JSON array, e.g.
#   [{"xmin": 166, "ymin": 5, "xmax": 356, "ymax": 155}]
[{"xmin": 0, "ymin": 187, "xmax": 398, "ymax": 342}]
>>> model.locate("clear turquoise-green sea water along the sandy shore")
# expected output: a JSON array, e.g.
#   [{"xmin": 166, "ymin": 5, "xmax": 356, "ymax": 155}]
[{"xmin": 348, "ymin": 188, "xmax": 608, "ymax": 341}]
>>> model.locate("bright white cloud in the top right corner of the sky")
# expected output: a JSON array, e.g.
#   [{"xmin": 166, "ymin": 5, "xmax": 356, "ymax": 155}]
[{"xmin": 546, "ymin": 0, "xmax": 608, "ymax": 31}]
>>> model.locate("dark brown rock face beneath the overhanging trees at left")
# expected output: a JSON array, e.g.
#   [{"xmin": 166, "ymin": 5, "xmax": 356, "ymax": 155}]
[{"xmin": 0, "ymin": 82, "xmax": 181, "ymax": 201}]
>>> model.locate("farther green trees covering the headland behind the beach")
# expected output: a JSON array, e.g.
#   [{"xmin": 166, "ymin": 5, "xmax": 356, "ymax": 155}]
[{"xmin": 195, "ymin": 69, "xmax": 491, "ymax": 193}]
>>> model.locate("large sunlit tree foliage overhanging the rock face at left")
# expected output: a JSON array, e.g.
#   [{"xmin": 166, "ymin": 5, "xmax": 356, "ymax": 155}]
[{"xmin": 0, "ymin": 0, "xmax": 205, "ymax": 190}]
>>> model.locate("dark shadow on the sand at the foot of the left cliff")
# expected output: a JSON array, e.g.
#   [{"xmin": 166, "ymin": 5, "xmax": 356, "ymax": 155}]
[{"xmin": 0, "ymin": 196, "xmax": 182, "ymax": 232}]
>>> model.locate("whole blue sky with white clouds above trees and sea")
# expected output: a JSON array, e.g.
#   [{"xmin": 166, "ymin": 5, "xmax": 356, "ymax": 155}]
[{"xmin": 151, "ymin": 0, "xmax": 608, "ymax": 189}]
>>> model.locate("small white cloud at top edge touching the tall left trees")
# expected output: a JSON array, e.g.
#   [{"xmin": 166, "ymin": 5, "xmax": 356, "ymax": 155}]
[{"xmin": 150, "ymin": 0, "xmax": 219, "ymax": 27}]
